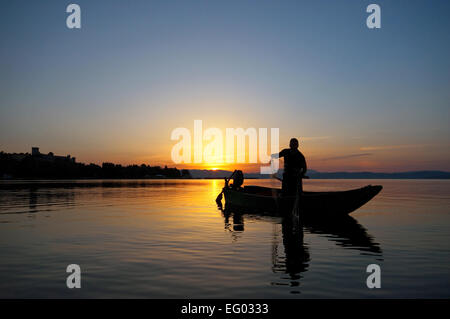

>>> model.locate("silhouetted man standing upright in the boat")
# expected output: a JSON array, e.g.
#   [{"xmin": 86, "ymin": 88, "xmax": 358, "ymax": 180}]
[{"xmin": 272, "ymin": 138, "xmax": 307, "ymax": 195}]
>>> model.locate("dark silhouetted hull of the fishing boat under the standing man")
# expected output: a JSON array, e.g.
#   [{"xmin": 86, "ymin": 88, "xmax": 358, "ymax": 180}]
[{"xmin": 223, "ymin": 185, "xmax": 382, "ymax": 217}]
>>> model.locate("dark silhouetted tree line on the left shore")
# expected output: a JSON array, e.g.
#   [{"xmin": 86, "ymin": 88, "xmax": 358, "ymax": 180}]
[{"xmin": 0, "ymin": 152, "xmax": 191, "ymax": 179}]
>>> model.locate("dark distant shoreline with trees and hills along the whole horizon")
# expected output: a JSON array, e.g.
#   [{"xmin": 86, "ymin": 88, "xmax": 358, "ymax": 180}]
[{"xmin": 0, "ymin": 152, "xmax": 450, "ymax": 181}]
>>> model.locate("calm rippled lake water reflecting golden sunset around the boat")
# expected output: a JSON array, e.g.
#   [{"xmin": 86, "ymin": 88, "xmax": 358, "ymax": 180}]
[{"xmin": 0, "ymin": 180, "xmax": 450, "ymax": 298}]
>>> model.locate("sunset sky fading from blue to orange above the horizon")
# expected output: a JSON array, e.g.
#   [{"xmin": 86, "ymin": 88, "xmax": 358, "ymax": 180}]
[{"xmin": 0, "ymin": 0, "xmax": 450, "ymax": 172}]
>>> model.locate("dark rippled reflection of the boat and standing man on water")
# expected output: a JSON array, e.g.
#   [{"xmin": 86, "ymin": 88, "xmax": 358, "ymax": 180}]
[{"xmin": 217, "ymin": 202, "xmax": 382, "ymax": 293}]
